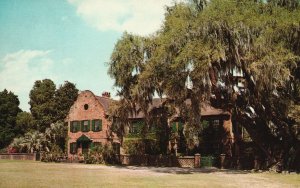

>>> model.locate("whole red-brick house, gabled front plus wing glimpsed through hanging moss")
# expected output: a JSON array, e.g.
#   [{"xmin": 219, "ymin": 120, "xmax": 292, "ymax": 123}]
[{"xmin": 65, "ymin": 90, "xmax": 233, "ymax": 158}]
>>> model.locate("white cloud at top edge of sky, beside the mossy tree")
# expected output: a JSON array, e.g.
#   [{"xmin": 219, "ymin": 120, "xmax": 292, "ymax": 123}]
[{"xmin": 68, "ymin": 0, "xmax": 173, "ymax": 35}]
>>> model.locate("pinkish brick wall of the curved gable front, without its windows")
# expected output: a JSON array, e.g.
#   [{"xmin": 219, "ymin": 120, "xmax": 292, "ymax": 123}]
[{"xmin": 66, "ymin": 91, "xmax": 109, "ymax": 157}]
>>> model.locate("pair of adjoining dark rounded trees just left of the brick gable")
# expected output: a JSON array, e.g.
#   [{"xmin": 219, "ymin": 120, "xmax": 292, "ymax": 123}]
[{"xmin": 29, "ymin": 79, "xmax": 78, "ymax": 132}]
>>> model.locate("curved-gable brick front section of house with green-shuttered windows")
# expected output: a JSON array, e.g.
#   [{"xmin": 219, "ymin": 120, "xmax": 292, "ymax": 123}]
[{"xmin": 65, "ymin": 90, "xmax": 118, "ymax": 158}]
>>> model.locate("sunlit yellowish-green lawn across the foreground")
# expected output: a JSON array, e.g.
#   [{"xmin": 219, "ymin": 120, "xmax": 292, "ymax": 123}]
[{"xmin": 0, "ymin": 160, "xmax": 300, "ymax": 188}]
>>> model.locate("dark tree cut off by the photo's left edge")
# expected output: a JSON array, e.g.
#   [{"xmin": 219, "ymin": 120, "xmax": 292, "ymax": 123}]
[{"xmin": 0, "ymin": 89, "xmax": 21, "ymax": 148}]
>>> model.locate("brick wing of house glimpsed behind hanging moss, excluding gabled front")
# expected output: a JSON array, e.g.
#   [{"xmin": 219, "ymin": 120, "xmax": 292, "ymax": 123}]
[{"xmin": 128, "ymin": 98, "xmax": 234, "ymax": 156}]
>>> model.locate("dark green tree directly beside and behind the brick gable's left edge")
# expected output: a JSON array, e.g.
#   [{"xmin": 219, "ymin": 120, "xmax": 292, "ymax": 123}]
[{"xmin": 54, "ymin": 81, "xmax": 78, "ymax": 122}]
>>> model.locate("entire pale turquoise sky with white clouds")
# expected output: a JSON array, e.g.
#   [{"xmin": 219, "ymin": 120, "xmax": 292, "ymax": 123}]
[{"xmin": 0, "ymin": 0, "xmax": 173, "ymax": 111}]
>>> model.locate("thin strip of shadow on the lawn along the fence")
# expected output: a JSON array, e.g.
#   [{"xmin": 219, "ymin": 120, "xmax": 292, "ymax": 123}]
[{"xmin": 110, "ymin": 166, "xmax": 251, "ymax": 174}]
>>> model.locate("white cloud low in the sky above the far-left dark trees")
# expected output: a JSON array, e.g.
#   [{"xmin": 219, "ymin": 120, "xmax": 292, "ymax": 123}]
[{"xmin": 0, "ymin": 50, "xmax": 56, "ymax": 110}]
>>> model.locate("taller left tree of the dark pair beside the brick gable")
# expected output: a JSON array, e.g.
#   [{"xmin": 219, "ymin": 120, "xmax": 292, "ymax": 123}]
[{"xmin": 29, "ymin": 79, "xmax": 56, "ymax": 132}]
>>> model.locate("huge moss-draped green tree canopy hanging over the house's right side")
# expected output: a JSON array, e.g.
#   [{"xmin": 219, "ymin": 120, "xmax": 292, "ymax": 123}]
[{"xmin": 109, "ymin": 0, "xmax": 300, "ymax": 167}]
